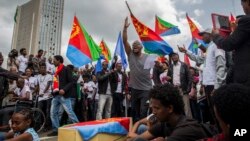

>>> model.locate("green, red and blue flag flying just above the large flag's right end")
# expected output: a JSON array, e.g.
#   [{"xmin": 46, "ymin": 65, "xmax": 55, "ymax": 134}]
[{"xmin": 155, "ymin": 16, "xmax": 181, "ymax": 36}]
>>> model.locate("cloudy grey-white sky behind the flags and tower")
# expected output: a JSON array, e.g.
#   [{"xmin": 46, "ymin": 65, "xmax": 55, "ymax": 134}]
[{"xmin": 0, "ymin": 0, "xmax": 243, "ymax": 66}]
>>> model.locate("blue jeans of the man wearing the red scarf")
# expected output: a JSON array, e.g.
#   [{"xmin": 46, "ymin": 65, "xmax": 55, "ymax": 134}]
[{"xmin": 50, "ymin": 95, "xmax": 79, "ymax": 132}]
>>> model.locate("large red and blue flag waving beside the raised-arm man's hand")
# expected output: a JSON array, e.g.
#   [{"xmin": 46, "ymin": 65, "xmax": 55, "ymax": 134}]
[{"xmin": 131, "ymin": 14, "xmax": 173, "ymax": 55}]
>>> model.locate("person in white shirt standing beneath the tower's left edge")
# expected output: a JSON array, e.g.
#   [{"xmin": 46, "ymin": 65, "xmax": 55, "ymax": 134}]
[{"xmin": 17, "ymin": 48, "xmax": 28, "ymax": 74}]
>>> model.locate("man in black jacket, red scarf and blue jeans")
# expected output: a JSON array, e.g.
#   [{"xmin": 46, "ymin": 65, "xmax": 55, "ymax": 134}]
[{"xmin": 48, "ymin": 55, "xmax": 79, "ymax": 136}]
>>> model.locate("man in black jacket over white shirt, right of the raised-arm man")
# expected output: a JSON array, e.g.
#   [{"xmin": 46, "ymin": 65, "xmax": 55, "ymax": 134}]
[{"xmin": 168, "ymin": 53, "xmax": 192, "ymax": 118}]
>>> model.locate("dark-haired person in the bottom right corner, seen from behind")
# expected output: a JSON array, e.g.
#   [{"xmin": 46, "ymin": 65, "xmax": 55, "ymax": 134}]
[{"xmin": 201, "ymin": 84, "xmax": 250, "ymax": 141}]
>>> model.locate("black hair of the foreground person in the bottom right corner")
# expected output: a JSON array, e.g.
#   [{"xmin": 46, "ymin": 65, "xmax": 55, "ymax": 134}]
[{"xmin": 212, "ymin": 84, "xmax": 250, "ymax": 129}]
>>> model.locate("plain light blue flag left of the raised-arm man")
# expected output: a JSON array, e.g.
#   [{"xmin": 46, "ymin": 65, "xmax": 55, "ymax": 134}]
[{"xmin": 114, "ymin": 32, "xmax": 128, "ymax": 70}]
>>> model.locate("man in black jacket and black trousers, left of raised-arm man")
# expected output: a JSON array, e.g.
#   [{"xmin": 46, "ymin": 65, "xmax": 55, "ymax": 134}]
[{"xmin": 111, "ymin": 62, "xmax": 127, "ymax": 117}]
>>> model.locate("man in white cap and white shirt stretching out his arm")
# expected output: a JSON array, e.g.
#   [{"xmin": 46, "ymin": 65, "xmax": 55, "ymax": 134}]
[{"xmin": 178, "ymin": 28, "xmax": 226, "ymax": 123}]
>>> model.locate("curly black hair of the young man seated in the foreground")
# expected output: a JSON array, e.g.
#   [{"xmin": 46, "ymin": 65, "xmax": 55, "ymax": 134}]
[{"xmin": 149, "ymin": 84, "xmax": 184, "ymax": 114}]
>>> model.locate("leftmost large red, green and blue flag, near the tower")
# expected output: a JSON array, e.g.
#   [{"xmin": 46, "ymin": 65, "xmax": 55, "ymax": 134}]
[{"xmin": 66, "ymin": 16, "xmax": 100, "ymax": 67}]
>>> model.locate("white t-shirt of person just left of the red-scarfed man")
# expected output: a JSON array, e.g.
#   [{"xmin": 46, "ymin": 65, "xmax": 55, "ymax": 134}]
[{"xmin": 37, "ymin": 74, "xmax": 52, "ymax": 101}]
